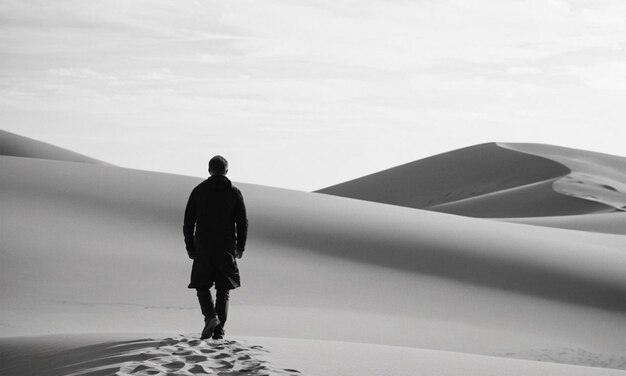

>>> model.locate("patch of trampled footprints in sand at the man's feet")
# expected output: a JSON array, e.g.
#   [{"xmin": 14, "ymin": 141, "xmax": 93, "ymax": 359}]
[{"xmin": 68, "ymin": 335, "xmax": 300, "ymax": 376}]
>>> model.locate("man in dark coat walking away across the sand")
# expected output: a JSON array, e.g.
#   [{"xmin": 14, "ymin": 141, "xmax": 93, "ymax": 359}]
[{"xmin": 183, "ymin": 155, "xmax": 248, "ymax": 339}]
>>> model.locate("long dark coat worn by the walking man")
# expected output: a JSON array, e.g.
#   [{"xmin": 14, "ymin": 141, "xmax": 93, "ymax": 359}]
[{"xmin": 183, "ymin": 175, "xmax": 248, "ymax": 289}]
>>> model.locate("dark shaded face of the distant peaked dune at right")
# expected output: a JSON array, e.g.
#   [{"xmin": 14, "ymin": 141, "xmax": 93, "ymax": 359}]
[{"xmin": 318, "ymin": 143, "xmax": 619, "ymax": 217}]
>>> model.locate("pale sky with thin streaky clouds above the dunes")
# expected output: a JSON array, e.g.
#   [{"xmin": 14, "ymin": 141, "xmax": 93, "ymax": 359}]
[{"xmin": 0, "ymin": 0, "xmax": 626, "ymax": 191}]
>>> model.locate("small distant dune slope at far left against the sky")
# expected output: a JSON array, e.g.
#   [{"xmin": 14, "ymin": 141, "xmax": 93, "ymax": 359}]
[{"xmin": 0, "ymin": 129, "xmax": 109, "ymax": 165}]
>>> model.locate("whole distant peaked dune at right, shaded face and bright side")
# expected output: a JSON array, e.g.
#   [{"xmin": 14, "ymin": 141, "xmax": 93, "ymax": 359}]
[{"xmin": 318, "ymin": 143, "xmax": 626, "ymax": 218}]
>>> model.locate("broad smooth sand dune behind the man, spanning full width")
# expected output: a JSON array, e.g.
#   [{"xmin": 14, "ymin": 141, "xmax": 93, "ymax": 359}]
[{"xmin": 0, "ymin": 137, "xmax": 626, "ymax": 375}]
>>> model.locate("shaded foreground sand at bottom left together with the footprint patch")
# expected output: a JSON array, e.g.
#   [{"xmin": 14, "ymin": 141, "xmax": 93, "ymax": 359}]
[{"xmin": 0, "ymin": 335, "xmax": 300, "ymax": 376}]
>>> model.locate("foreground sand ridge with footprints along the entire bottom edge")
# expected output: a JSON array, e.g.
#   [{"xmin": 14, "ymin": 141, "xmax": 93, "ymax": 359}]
[{"xmin": 0, "ymin": 335, "xmax": 623, "ymax": 376}]
